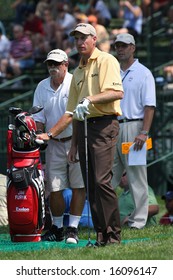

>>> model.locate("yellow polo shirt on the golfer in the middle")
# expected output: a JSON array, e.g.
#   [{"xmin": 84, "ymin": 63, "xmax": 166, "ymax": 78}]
[{"xmin": 66, "ymin": 48, "xmax": 123, "ymax": 118}]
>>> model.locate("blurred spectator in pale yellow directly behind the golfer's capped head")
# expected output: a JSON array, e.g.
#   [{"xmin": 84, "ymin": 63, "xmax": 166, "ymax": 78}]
[{"xmin": 88, "ymin": 15, "xmax": 110, "ymax": 52}]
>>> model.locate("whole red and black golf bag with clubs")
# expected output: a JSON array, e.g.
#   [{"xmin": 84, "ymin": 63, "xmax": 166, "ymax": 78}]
[{"xmin": 7, "ymin": 107, "xmax": 45, "ymax": 242}]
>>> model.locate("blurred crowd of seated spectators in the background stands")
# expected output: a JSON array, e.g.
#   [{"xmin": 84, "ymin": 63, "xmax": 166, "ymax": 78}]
[{"xmin": 0, "ymin": 0, "xmax": 173, "ymax": 78}]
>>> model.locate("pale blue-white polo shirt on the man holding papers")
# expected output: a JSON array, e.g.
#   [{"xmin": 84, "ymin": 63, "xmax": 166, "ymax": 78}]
[{"xmin": 120, "ymin": 59, "xmax": 156, "ymax": 119}]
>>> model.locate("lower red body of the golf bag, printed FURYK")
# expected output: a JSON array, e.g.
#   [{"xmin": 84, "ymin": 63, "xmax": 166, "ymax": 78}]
[{"xmin": 7, "ymin": 166, "xmax": 45, "ymax": 241}]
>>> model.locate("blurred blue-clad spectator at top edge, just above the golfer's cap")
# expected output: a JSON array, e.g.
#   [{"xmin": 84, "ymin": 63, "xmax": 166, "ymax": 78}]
[{"xmin": 88, "ymin": 0, "xmax": 112, "ymax": 28}]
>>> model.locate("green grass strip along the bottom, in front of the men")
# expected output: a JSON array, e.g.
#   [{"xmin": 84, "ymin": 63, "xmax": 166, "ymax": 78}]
[{"xmin": 0, "ymin": 195, "xmax": 173, "ymax": 260}]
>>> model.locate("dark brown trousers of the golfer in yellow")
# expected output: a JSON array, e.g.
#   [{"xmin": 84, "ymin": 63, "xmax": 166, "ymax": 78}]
[{"xmin": 78, "ymin": 117, "xmax": 121, "ymax": 242}]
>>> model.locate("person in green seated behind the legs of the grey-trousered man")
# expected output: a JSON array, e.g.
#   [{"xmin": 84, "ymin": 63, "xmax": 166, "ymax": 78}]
[{"xmin": 118, "ymin": 172, "xmax": 159, "ymax": 228}]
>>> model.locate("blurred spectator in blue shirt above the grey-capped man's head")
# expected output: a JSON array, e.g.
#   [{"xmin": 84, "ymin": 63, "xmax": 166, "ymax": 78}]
[{"xmin": 112, "ymin": 0, "xmax": 143, "ymax": 39}]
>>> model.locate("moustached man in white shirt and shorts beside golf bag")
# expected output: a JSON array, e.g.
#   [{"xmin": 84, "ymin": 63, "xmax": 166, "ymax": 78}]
[{"xmin": 33, "ymin": 49, "xmax": 85, "ymax": 243}]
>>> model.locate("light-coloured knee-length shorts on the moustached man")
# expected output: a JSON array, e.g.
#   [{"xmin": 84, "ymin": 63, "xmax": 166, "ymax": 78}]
[{"xmin": 45, "ymin": 140, "xmax": 84, "ymax": 192}]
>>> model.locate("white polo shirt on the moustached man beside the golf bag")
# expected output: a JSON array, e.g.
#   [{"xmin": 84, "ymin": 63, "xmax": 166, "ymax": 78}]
[{"xmin": 33, "ymin": 72, "xmax": 72, "ymax": 138}]
